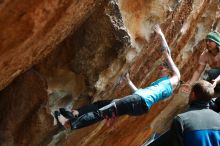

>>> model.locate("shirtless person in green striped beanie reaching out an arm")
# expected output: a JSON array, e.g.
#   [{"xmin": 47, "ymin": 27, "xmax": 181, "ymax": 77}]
[{"xmin": 181, "ymin": 31, "xmax": 220, "ymax": 112}]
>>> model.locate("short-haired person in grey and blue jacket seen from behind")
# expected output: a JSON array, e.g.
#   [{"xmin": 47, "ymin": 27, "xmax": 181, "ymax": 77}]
[{"xmin": 148, "ymin": 80, "xmax": 220, "ymax": 146}]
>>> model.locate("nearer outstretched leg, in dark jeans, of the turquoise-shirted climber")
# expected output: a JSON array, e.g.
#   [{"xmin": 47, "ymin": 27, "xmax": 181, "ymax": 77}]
[{"xmin": 70, "ymin": 94, "xmax": 148, "ymax": 129}]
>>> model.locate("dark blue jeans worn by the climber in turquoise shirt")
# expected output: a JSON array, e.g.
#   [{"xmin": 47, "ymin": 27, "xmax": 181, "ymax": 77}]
[{"xmin": 70, "ymin": 94, "xmax": 148, "ymax": 129}]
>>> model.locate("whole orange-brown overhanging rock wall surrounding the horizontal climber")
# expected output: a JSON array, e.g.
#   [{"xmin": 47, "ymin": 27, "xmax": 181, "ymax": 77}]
[{"xmin": 0, "ymin": 0, "xmax": 220, "ymax": 146}]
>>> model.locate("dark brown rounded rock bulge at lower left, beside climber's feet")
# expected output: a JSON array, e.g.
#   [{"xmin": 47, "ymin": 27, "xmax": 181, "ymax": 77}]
[{"xmin": 0, "ymin": 70, "xmax": 56, "ymax": 145}]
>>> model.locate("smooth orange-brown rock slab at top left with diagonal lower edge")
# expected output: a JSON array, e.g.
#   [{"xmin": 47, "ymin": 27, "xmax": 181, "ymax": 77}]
[{"xmin": 0, "ymin": 0, "xmax": 102, "ymax": 89}]
